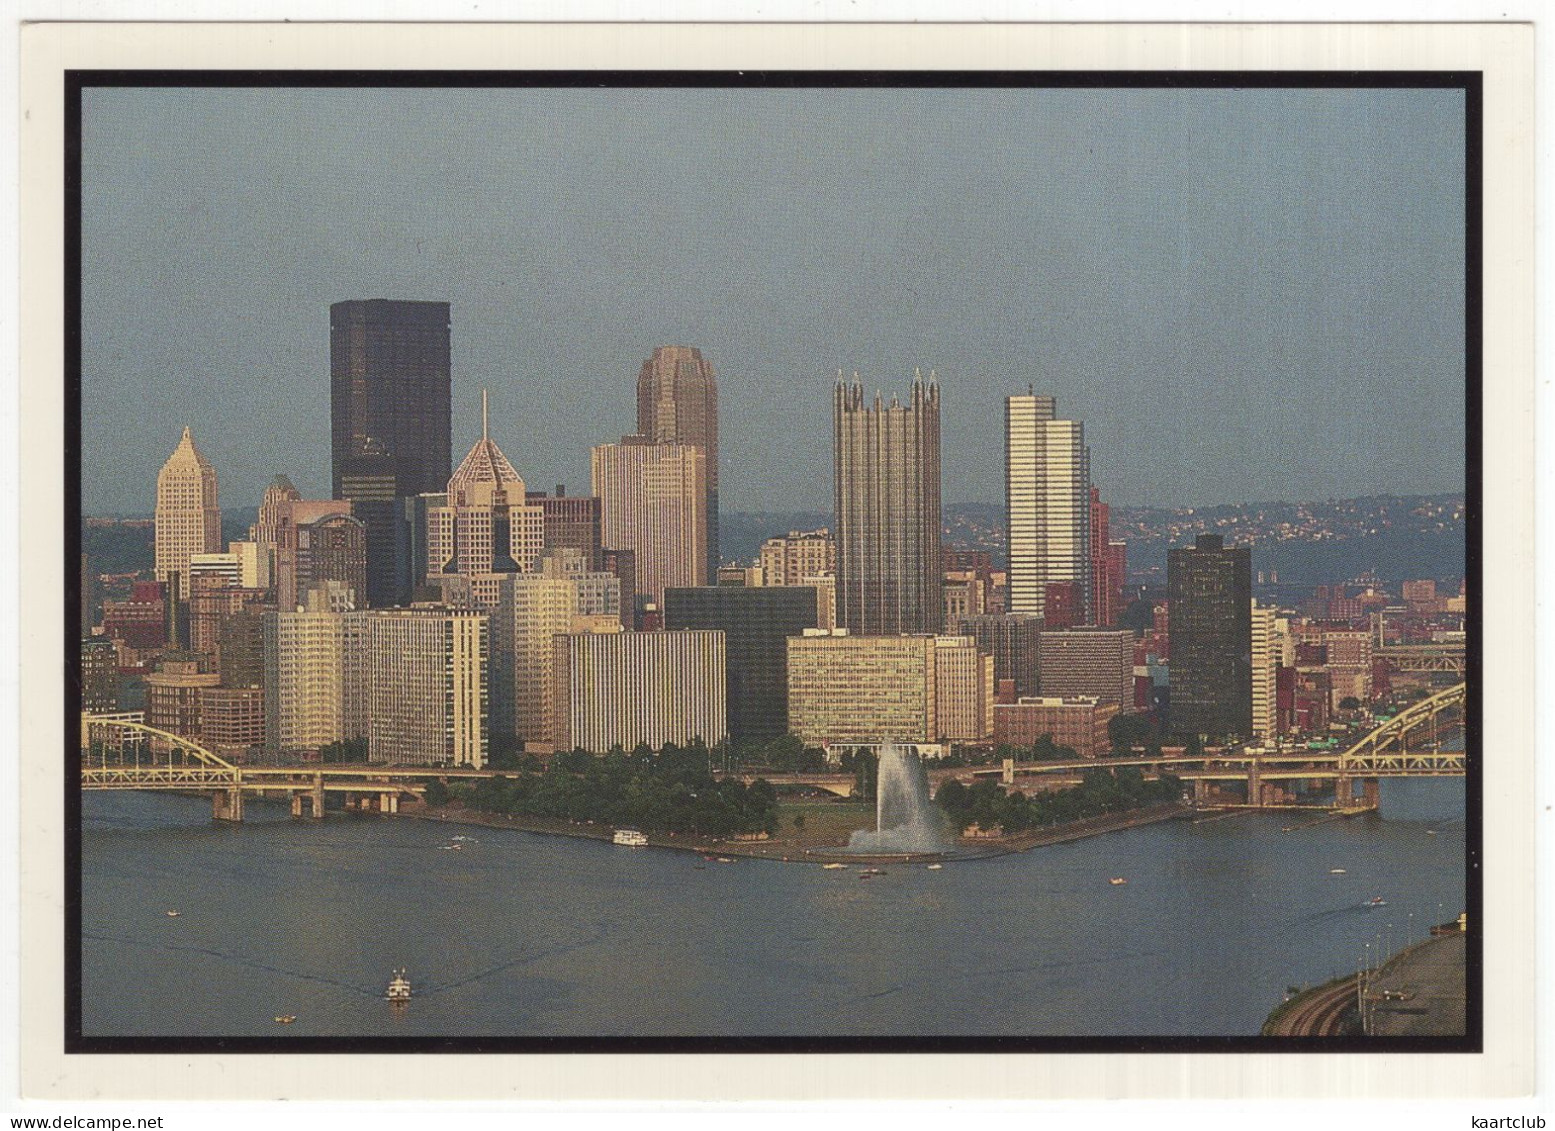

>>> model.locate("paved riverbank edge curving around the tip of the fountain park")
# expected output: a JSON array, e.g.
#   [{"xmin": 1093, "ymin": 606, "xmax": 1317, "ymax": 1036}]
[{"xmin": 400, "ymin": 803, "xmax": 1193, "ymax": 863}]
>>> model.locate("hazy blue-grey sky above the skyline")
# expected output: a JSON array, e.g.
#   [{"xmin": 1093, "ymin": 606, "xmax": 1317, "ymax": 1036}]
[{"xmin": 82, "ymin": 81, "xmax": 1467, "ymax": 513}]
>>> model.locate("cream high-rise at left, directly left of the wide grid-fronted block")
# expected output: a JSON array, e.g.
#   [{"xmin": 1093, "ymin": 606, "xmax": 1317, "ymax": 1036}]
[{"xmin": 264, "ymin": 588, "xmax": 345, "ymax": 761}]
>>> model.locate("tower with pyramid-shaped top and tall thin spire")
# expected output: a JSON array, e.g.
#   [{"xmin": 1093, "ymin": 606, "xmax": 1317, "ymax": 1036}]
[{"xmin": 426, "ymin": 392, "xmax": 544, "ymax": 610}]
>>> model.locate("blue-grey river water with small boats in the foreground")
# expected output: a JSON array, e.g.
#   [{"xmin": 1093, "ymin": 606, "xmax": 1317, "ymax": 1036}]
[{"xmin": 82, "ymin": 778, "xmax": 1465, "ymax": 1038}]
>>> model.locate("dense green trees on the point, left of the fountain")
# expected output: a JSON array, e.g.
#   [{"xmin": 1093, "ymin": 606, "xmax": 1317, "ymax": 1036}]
[{"xmin": 426, "ymin": 741, "xmax": 778, "ymax": 837}]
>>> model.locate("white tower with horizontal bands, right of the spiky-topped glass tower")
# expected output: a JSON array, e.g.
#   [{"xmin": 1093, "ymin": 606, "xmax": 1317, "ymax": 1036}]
[{"xmin": 1005, "ymin": 395, "xmax": 1090, "ymax": 625}]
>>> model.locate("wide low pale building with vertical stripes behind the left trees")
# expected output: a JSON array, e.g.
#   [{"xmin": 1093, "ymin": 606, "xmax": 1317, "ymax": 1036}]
[{"xmin": 552, "ymin": 631, "xmax": 729, "ymax": 755}]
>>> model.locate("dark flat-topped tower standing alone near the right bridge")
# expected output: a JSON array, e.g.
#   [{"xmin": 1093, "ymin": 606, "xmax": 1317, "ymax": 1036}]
[{"xmin": 1166, "ymin": 534, "xmax": 1253, "ymax": 739}]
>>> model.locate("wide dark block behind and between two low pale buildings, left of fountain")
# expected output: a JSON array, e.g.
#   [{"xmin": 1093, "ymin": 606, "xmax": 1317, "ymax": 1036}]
[{"xmin": 664, "ymin": 585, "xmax": 816, "ymax": 737}]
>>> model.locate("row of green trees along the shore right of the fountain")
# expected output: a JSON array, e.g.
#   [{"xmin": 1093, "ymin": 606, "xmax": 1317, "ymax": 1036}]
[{"xmin": 935, "ymin": 765, "xmax": 1182, "ymax": 832}]
